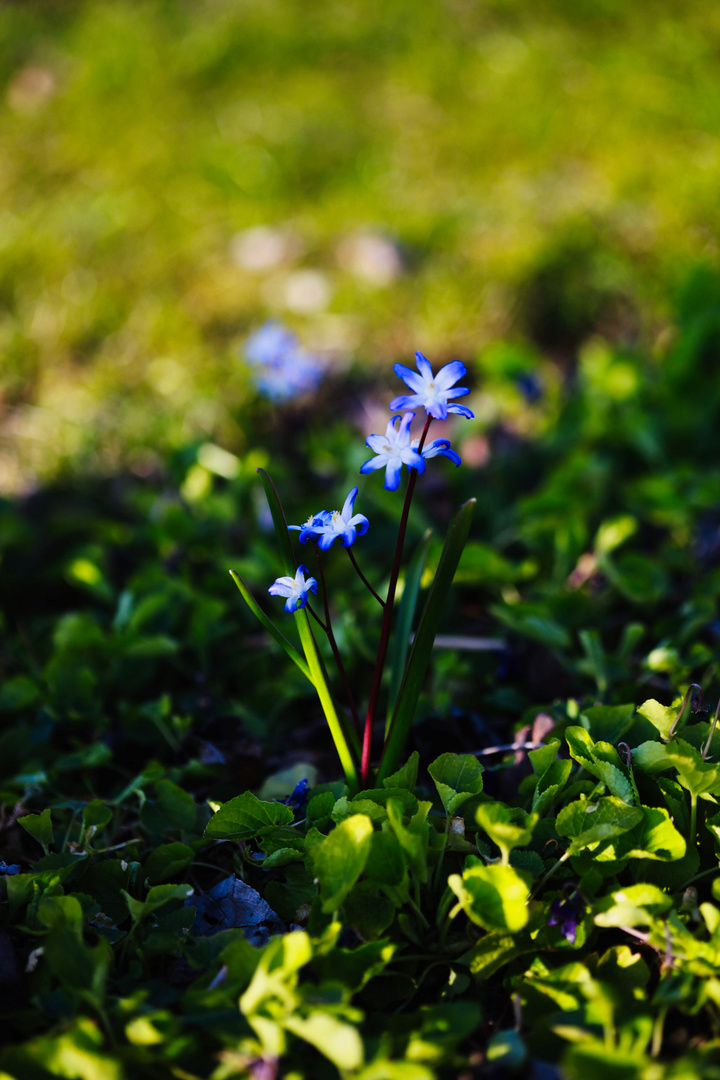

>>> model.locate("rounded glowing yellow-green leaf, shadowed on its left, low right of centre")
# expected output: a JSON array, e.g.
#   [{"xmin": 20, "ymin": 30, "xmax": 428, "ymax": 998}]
[{"xmin": 448, "ymin": 863, "xmax": 530, "ymax": 933}]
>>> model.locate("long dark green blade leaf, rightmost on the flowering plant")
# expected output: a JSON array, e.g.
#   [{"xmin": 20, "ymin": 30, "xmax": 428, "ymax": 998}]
[{"xmin": 378, "ymin": 499, "xmax": 476, "ymax": 782}]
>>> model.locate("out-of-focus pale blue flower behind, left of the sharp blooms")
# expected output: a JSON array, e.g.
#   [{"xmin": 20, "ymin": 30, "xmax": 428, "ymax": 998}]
[{"xmin": 245, "ymin": 320, "xmax": 325, "ymax": 402}]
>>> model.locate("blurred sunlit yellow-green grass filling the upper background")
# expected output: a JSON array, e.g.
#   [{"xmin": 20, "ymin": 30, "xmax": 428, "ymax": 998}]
[{"xmin": 0, "ymin": 0, "xmax": 720, "ymax": 491}]
